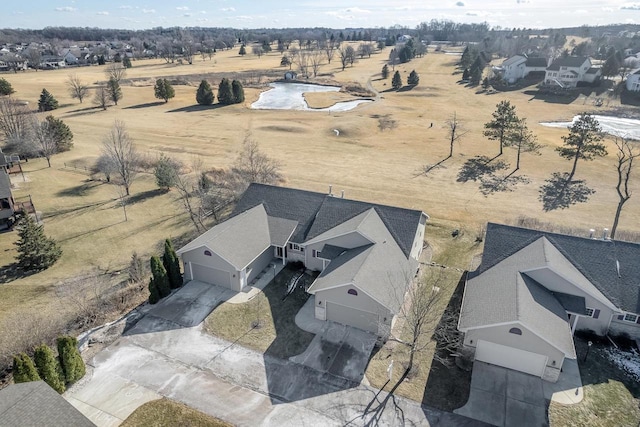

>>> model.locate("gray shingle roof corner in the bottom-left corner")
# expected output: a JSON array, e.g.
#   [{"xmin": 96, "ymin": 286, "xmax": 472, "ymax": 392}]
[{"xmin": 0, "ymin": 381, "xmax": 95, "ymax": 427}]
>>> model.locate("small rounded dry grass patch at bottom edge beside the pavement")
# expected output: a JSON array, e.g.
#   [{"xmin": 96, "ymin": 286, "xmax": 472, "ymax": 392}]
[{"xmin": 120, "ymin": 399, "xmax": 232, "ymax": 427}]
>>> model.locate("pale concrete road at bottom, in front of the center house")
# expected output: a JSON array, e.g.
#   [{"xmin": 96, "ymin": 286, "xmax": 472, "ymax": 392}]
[{"xmin": 65, "ymin": 282, "xmax": 481, "ymax": 426}]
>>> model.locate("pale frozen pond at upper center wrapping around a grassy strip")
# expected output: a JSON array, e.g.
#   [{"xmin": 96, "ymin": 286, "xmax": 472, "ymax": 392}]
[{"xmin": 251, "ymin": 83, "xmax": 372, "ymax": 111}]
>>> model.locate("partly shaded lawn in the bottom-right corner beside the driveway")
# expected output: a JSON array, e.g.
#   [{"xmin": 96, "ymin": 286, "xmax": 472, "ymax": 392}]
[{"xmin": 549, "ymin": 338, "xmax": 640, "ymax": 427}]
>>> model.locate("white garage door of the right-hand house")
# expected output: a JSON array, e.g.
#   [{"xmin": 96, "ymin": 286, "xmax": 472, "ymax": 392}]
[{"xmin": 476, "ymin": 340, "xmax": 547, "ymax": 377}]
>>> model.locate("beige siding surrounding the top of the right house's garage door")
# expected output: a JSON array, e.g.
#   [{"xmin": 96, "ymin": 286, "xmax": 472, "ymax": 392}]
[{"xmin": 464, "ymin": 323, "xmax": 564, "ymax": 367}]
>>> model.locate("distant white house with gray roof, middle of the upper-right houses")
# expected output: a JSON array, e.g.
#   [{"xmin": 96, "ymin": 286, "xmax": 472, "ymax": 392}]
[{"xmin": 544, "ymin": 56, "xmax": 602, "ymax": 89}]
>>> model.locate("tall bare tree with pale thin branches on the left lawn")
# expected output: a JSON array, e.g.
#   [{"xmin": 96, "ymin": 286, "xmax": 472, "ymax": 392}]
[{"xmin": 102, "ymin": 120, "xmax": 140, "ymax": 196}]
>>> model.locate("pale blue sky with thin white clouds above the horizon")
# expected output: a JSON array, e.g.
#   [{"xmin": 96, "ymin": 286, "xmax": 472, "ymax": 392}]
[{"xmin": 0, "ymin": 0, "xmax": 640, "ymax": 29}]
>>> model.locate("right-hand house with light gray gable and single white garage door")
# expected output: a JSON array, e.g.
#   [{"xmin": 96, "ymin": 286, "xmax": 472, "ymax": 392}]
[{"xmin": 458, "ymin": 223, "xmax": 640, "ymax": 382}]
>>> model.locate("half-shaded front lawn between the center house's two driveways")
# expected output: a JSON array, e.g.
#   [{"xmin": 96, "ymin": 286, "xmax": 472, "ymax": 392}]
[{"xmin": 204, "ymin": 266, "xmax": 314, "ymax": 359}]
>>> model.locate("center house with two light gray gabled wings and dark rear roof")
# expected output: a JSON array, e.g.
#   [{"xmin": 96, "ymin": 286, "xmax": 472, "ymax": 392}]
[{"xmin": 177, "ymin": 184, "xmax": 428, "ymax": 336}]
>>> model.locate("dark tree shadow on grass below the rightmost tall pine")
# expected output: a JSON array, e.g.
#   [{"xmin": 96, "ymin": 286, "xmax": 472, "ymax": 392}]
[{"xmin": 538, "ymin": 172, "xmax": 595, "ymax": 212}]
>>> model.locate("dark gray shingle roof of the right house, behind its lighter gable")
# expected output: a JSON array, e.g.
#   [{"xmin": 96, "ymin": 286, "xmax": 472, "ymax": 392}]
[{"xmin": 478, "ymin": 223, "xmax": 640, "ymax": 313}]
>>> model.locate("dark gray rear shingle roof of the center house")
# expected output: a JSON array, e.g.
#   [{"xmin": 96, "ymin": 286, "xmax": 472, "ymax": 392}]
[{"xmin": 232, "ymin": 183, "xmax": 422, "ymax": 257}]
